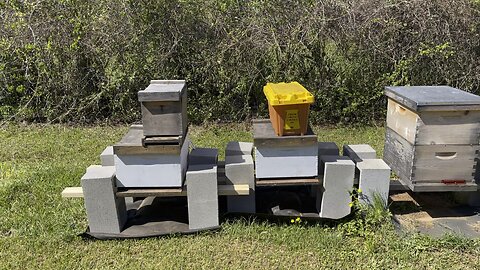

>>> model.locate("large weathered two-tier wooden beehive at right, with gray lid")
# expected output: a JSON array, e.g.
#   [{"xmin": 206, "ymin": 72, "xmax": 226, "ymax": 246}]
[{"xmin": 384, "ymin": 86, "xmax": 480, "ymax": 192}]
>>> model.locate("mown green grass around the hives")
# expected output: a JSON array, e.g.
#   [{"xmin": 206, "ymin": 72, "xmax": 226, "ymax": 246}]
[{"xmin": 0, "ymin": 124, "xmax": 480, "ymax": 269}]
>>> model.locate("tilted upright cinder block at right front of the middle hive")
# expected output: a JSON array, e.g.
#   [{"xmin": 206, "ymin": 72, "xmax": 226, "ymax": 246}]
[{"xmin": 317, "ymin": 156, "xmax": 355, "ymax": 219}]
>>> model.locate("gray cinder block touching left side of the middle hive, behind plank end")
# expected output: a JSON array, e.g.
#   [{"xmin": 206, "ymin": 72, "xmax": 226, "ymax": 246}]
[{"xmin": 225, "ymin": 155, "xmax": 256, "ymax": 213}]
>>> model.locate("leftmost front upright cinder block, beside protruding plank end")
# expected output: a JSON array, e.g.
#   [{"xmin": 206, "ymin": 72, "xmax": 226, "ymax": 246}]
[{"xmin": 81, "ymin": 166, "xmax": 127, "ymax": 233}]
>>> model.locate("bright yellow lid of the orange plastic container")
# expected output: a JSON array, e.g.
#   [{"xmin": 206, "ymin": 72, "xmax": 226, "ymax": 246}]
[{"xmin": 263, "ymin": 82, "xmax": 314, "ymax": 106}]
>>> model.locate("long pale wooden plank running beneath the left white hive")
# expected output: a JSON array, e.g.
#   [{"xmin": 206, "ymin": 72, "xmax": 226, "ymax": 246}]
[{"xmin": 62, "ymin": 185, "xmax": 250, "ymax": 198}]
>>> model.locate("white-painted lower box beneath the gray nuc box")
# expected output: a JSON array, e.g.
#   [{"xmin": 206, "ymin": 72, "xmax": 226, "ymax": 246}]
[{"xmin": 114, "ymin": 138, "xmax": 190, "ymax": 187}]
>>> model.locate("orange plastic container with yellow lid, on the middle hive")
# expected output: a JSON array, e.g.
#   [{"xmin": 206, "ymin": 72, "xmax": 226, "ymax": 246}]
[{"xmin": 263, "ymin": 82, "xmax": 315, "ymax": 136}]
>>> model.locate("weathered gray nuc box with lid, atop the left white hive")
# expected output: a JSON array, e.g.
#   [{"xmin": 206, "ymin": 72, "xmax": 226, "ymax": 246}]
[{"xmin": 138, "ymin": 80, "xmax": 188, "ymax": 137}]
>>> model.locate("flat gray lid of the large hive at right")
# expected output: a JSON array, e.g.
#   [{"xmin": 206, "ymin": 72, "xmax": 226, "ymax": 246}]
[{"xmin": 385, "ymin": 86, "xmax": 480, "ymax": 111}]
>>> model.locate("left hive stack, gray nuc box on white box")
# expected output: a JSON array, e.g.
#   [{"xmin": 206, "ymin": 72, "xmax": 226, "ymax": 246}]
[{"xmin": 113, "ymin": 80, "xmax": 189, "ymax": 187}]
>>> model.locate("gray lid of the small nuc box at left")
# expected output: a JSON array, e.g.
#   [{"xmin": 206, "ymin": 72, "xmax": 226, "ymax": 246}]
[{"xmin": 138, "ymin": 80, "xmax": 186, "ymax": 102}]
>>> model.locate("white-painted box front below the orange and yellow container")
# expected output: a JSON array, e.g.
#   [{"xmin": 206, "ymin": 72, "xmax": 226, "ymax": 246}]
[{"xmin": 255, "ymin": 144, "xmax": 318, "ymax": 178}]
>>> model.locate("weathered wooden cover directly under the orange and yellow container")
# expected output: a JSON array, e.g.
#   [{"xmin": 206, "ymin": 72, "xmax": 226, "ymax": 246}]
[{"xmin": 253, "ymin": 119, "xmax": 318, "ymax": 147}]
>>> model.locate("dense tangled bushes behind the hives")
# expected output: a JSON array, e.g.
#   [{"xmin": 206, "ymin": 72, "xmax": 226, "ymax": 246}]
[{"xmin": 0, "ymin": 0, "xmax": 480, "ymax": 123}]
